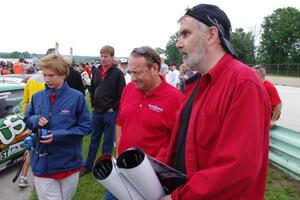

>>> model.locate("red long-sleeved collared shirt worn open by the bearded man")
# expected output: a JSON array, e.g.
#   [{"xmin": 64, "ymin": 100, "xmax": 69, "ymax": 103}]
[{"xmin": 166, "ymin": 54, "xmax": 271, "ymax": 200}]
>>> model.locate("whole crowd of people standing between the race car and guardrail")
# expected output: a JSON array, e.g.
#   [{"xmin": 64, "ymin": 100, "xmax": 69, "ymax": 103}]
[{"xmin": 5, "ymin": 4, "xmax": 281, "ymax": 200}]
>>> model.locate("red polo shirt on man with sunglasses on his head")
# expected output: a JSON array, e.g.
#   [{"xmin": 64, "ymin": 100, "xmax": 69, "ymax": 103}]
[{"xmin": 117, "ymin": 77, "xmax": 183, "ymax": 157}]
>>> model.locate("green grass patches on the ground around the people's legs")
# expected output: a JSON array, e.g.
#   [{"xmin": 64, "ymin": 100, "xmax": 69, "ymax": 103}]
[{"xmin": 31, "ymin": 95, "xmax": 300, "ymax": 200}]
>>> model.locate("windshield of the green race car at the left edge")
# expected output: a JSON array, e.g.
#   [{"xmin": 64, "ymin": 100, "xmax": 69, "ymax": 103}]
[{"xmin": 0, "ymin": 90, "xmax": 23, "ymax": 118}]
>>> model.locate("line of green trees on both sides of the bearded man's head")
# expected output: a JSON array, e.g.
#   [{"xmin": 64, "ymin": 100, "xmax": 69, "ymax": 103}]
[{"xmin": 156, "ymin": 7, "xmax": 300, "ymax": 65}]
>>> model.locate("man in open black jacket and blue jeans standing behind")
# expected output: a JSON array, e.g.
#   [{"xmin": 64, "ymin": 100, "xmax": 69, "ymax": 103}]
[{"xmin": 80, "ymin": 45, "xmax": 125, "ymax": 176}]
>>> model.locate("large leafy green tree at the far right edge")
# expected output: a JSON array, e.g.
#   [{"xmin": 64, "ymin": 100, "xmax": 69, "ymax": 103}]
[{"xmin": 258, "ymin": 7, "xmax": 300, "ymax": 63}]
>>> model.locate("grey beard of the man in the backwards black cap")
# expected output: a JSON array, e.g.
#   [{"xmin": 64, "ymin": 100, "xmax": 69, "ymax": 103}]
[{"xmin": 181, "ymin": 42, "xmax": 206, "ymax": 72}]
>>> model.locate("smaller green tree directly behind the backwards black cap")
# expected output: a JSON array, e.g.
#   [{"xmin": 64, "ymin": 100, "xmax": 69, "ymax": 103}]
[{"xmin": 231, "ymin": 28, "xmax": 256, "ymax": 64}]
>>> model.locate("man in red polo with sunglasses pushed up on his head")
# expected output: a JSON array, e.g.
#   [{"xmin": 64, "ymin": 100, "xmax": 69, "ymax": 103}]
[{"xmin": 116, "ymin": 46, "xmax": 183, "ymax": 157}]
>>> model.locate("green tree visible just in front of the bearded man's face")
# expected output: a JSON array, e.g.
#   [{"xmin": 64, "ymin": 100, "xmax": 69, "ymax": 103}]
[{"xmin": 165, "ymin": 33, "xmax": 182, "ymax": 66}]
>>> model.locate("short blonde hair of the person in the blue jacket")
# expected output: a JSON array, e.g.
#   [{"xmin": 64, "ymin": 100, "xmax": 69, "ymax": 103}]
[{"xmin": 39, "ymin": 53, "xmax": 70, "ymax": 76}]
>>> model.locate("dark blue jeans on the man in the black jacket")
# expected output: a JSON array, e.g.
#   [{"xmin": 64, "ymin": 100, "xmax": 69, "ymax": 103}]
[{"xmin": 85, "ymin": 111, "xmax": 117, "ymax": 171}]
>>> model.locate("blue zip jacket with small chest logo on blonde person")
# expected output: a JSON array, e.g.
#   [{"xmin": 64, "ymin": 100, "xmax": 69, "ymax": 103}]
[{"xmin": 24, "ymin": 82, "xmax": 91, "ymax": 175}]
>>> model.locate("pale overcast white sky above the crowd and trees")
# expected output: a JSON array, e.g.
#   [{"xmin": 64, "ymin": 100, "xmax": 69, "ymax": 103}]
[{"xmin": 0, "ymin": 0, "xmax": 300, "ymax": 57}]
